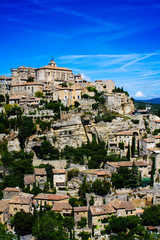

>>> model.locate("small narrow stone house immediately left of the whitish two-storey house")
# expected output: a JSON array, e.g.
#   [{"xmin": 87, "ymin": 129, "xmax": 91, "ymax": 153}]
[{"xmin": 34, "ymin": 168, "xmax": 47, "ymax": 189}]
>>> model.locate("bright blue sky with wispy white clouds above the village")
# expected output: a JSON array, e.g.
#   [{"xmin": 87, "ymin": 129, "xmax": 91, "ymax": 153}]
[{"xmin": 0, "ymin": 0, "xmax": 160, "ymax": 99}]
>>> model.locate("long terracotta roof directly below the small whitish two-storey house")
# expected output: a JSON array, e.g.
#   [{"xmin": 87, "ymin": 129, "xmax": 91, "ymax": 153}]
[{"xmin": 34, "ymin": 193, "xmax": 69, "ymax": 201}]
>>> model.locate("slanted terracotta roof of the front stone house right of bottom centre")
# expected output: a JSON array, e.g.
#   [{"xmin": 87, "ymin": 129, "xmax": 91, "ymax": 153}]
[{"xmin": 90, "ymin": 204, "xmax": 116, "ymax": 216}]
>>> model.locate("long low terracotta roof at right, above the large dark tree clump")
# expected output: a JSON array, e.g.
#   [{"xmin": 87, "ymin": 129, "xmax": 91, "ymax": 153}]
[{"xmin": 107, "ymin": 161, "xmax": 148, "ymax": 168}]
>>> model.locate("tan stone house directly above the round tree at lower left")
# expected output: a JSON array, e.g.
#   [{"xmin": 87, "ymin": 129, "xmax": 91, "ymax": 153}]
[{"xmin": 9, "ymin": 193, "xmax": 34, "ymax": 217}]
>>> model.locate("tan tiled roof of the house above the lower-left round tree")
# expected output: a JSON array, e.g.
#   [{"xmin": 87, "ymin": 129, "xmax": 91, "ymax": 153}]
[{"xmin": 9, "ymin": 193, "xmax": 34, "ymax": 205}]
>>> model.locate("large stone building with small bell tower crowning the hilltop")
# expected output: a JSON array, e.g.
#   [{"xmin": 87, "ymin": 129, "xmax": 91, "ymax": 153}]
[{"xmin": 35, "ymin": 59, "xmax": 74, "ymax": 85}]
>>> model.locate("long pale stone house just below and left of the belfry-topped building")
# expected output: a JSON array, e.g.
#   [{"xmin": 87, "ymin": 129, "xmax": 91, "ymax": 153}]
[{"xmin": 10, "ymin": 82, "xmax": 43, "ymax": 97}]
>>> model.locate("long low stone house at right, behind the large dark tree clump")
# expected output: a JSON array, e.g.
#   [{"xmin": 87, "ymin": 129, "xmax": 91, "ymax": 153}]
[{"xmin": 105, "ymin": 160, "xmax": 150, "ymax": 177}]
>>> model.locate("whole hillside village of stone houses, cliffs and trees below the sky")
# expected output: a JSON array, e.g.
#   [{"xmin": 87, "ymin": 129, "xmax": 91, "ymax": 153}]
[{"xmin": 0, "ymin": 59, "xmax": 160, "ymax": 240}]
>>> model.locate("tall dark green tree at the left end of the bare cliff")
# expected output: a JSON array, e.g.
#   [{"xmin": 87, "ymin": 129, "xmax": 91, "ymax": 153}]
[{"xmin": 18, "ymin": 117, "xmax": 36, "ymax": 149}]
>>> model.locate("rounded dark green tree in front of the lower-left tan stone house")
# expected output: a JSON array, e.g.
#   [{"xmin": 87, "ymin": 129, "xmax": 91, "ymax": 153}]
[{"xmin": 11, "ymin": 211, "xmax": 34, "ymax": 236}]
